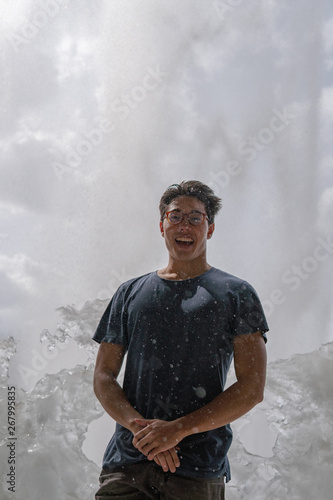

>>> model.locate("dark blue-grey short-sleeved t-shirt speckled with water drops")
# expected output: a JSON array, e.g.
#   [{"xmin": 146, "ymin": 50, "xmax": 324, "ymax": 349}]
[{"xmin": 94, "ymin": 268, "xmax": 268, "ymax": 481}]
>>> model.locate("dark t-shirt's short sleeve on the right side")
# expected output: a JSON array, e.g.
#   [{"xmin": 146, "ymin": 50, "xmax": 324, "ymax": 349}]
[{"xmin": 233, "ymin": 281, "xmax": 269, "ymax": 342}]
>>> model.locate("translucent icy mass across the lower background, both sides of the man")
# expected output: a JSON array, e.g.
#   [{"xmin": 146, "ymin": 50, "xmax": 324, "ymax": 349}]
[{"xmin": 0, "ymin": 301, "xmax": 333, "ymax": 500}]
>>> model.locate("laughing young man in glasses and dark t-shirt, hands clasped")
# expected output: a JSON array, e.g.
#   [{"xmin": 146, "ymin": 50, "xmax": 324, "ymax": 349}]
[{"xmin": 94, "ymin": 181, "xmax": 268, "ymax": 500}]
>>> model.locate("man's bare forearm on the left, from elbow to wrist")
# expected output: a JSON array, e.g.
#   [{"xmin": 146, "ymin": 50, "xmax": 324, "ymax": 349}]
[{"xmin": 94, "ymin": 372, "xmax": 142, "ymax": 434}]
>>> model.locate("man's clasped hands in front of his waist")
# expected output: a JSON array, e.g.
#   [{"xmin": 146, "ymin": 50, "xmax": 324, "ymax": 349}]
[{"xmin": 133, "ymin": 418, "xmax": 183, "ymax": 470}]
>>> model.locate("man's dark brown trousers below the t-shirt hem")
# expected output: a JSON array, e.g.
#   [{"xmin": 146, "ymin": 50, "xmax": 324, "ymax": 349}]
[{"xmin": 95, "ymin": 462, "xmax": 224, "ymax": 500}]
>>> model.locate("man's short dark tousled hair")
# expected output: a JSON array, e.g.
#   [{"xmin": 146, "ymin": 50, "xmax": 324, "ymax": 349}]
[{"xmin": 159, "ymin": 181, "xmax": 222, "ymax": 224}]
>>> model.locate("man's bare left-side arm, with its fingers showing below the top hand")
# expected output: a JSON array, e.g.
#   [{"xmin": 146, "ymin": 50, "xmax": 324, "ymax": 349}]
[{"xmin": 94, "ymin": 342, "xmax": 180, "ymax": 472}]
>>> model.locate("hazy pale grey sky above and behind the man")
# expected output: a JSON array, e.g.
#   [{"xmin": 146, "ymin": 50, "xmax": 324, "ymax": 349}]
[{"xmin": 0, "ymin": 0, "xmax": 333, "ymax": 388}]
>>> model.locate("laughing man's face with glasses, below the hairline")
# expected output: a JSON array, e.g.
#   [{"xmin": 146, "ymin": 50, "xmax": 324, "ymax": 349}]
[{"xmin": 160, "ymin": 196, "xmax": 214, "ymax": 261}]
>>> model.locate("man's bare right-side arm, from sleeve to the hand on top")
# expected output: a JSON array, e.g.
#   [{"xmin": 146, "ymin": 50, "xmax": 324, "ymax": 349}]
[{"xmin": 133, "ymin": 332, "xmax": 266, "ymax": 459}]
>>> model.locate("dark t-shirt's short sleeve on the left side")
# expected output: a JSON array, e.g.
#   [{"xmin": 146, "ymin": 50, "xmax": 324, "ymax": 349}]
[{"xmin": 93, "ymin": 286, "xmax": 128, "ymax": 348}]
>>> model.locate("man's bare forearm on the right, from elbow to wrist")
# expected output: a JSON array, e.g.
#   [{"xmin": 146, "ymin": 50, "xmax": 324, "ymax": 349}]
[{"xmin": 177, "ymin": 381, "xmax": 263, "ymax": 437}]
